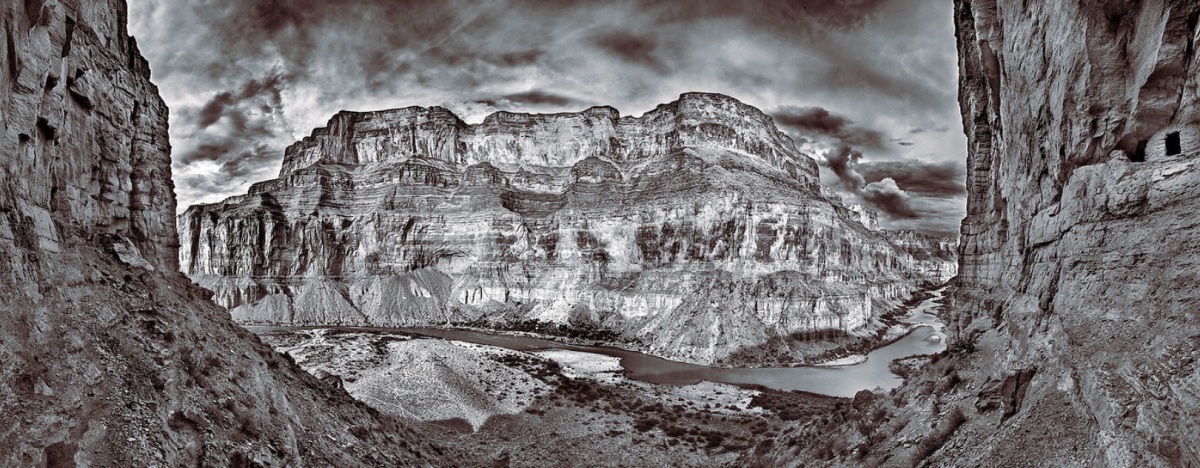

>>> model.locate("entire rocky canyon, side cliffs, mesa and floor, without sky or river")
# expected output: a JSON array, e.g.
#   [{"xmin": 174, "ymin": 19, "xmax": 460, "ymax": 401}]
[{"xmin": 0, "ymin": 0, "xmax": 1200, "ymax": 467}]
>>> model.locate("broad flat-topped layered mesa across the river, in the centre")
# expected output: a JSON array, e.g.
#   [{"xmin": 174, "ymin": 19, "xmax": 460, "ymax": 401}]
[{"xmin": 179, "ymin": 94, "xmax": 955, "ymax": 362}]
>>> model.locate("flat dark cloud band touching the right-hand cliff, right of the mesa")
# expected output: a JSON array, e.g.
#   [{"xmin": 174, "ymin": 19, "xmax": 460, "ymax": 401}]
[{"xmin": 854, "ymin": 160, "xmax": 967, "ymax": 198}]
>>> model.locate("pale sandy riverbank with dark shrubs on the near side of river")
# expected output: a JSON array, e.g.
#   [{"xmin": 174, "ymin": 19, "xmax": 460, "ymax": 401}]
[{"xmin": 258, "ymin": 328, "xmax": 830, "ymax": 466}]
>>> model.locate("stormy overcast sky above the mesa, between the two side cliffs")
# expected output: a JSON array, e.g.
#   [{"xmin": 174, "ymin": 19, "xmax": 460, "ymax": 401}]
[{"xmin": 130, "ymin": 0, "xmax": 966, "ymax": 233}]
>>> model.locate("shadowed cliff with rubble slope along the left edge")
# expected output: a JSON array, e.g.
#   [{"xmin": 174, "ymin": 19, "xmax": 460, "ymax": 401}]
[{"xmin": 0, "ymin": 0, "xmax": 453, "ymax": 467}]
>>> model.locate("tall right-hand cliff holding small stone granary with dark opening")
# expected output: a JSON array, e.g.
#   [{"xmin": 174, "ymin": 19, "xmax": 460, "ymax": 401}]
[{"xmin": 950, "ymin": 0, "xmax": 1200, "ymax": 466}]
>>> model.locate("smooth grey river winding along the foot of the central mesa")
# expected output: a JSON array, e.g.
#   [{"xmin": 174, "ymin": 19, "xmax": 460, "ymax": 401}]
[{"xmin": 247, "ymin": 288, "xmax": 946, "ymax": 397}]
